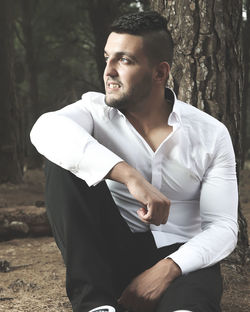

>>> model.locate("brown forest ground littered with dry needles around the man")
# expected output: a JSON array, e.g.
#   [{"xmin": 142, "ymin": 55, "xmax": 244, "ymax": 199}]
[{"xmin": 0, "ymin": 164, "xmax": 250, "ymax": 312}]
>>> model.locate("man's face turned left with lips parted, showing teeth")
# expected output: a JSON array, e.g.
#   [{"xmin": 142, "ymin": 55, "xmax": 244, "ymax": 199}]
[{"xmin": 103, "ymin": 32, "xmax": 152, "ymax": 110}]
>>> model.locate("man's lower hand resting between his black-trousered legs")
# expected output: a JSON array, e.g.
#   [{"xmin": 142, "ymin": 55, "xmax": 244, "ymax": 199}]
[{"xmin": 118, "ymin": 259, "xmax": 181, "ymax": 312}]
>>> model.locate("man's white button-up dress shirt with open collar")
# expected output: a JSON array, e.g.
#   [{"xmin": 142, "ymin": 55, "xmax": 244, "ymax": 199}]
[{"xmin": 31, "ymin": 89, "xmax": 238, "ymax": 274}]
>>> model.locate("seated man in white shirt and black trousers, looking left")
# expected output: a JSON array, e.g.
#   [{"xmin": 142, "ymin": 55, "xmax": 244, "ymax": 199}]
[{"xmin": 31, "ymin": 12, "xmax": 237, "ymax": 312}]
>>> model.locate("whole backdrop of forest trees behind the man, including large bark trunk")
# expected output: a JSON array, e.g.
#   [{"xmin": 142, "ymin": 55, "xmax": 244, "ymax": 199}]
[{"xmin": 0, "ymin": 0, "xmax": 250, "ymax": 260}]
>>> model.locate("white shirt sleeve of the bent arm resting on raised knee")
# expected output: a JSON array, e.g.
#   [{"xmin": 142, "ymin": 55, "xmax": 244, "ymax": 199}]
[{"xmin": 30, "ymin": 96, "xmax": 122, "ymax": 186}]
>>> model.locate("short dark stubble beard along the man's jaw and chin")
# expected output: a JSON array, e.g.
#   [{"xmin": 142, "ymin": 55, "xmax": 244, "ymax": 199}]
[{"xmin": 105, "ymin": 74, "xmax": 152, "ymax": 110}]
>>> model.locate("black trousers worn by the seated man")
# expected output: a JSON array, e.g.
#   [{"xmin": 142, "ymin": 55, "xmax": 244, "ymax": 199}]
[{"xmin": 45, "ymin": 161, "xmax": 222, "ymax": 312}]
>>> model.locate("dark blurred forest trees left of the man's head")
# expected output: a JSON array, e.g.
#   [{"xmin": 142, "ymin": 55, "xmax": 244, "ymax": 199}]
[{"xmin": 0, "ymin": 0, "xmax": 150, "ymax": 174}]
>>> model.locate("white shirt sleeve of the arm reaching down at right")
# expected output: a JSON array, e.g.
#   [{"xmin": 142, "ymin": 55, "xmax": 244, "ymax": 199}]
[{"xmin": 169, "ymin": 126, "xmax": 238, "ymax": 274}]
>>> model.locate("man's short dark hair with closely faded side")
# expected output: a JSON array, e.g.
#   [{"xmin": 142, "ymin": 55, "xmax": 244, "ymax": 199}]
[{"xmin": 110, "ymin": 11, "xmax": 173, "ymax": 65}]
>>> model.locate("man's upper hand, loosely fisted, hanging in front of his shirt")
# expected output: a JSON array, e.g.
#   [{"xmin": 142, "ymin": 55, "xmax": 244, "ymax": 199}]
[{"xmin": 107, "ymin": 162, "xmax": 170, "ymax": 225}]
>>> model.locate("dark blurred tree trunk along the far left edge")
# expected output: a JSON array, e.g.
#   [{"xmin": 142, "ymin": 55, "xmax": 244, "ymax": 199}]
[{"xmin": 0, "ymin": 0, "xmax": 22, "ymax": 183}]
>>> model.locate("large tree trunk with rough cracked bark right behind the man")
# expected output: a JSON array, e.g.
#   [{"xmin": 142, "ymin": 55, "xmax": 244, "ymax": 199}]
[{"xmin": 151, "ymin": 0, "xmax": 248, "ymax": 263}]
